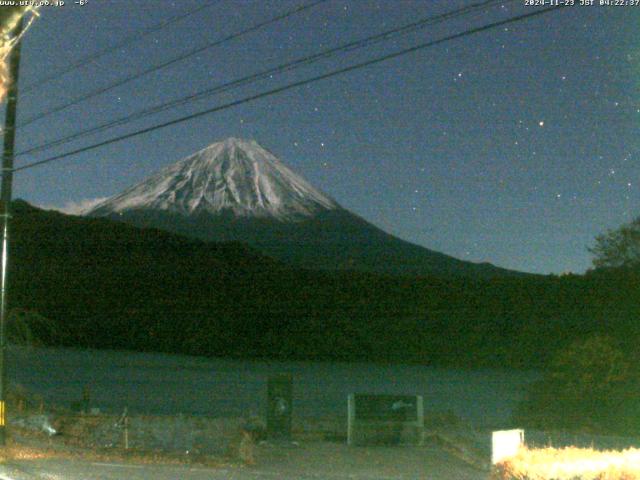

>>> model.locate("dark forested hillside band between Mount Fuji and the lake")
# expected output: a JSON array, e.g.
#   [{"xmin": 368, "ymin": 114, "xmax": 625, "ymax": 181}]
[{"xmin": 10, "ymin": 202, "xmax": 640, "ymax": 368}]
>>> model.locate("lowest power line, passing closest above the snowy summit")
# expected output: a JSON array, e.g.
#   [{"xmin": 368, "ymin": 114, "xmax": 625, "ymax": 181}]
[{"xmin": 12, "ymin": 5, "xmax": 564, "ymax": 172}]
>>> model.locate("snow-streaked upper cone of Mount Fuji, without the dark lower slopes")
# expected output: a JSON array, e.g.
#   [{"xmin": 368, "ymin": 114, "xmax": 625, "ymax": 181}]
[{"xmin": 87, "ymin": 138, "xmax": 340, "ymax": 221}]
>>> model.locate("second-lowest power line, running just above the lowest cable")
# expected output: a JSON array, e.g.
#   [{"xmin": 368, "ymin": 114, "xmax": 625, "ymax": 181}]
[{"xmin": 17, "ymin": 0, "xmax": 515, "ymax": 156}]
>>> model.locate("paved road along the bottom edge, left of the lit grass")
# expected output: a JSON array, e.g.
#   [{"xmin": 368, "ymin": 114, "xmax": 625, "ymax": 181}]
[{"xmin": 0, "ymin": 448, "xmax": 488, "ymax": 480}]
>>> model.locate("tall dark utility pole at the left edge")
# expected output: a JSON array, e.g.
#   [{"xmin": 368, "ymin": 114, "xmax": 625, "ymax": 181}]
[{"xmin": 0, "ymin": 19, "xmax": 22, "ymax": 446}]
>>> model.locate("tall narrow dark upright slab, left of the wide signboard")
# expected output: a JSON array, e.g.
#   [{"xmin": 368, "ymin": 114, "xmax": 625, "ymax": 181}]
[{"xmin": 267, "ymin": 375, "xmax": 293, "ymax": 440}]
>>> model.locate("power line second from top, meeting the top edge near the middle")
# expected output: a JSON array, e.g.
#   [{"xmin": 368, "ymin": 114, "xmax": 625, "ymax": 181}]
[{"xmin": 18, "ymin": 0, "xmax": 329, "ymax": 127}]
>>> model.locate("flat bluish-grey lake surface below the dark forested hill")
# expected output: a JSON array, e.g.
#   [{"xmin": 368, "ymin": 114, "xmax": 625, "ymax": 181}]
[{"xmin": 7, "ymin": 347, "xmax": 537, "ymax": 427}]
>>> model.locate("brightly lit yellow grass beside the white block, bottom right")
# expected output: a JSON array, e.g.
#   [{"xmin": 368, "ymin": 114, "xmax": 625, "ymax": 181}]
[{"xmin": 492, "ymin": 447, "xmax": 640, "ymax": 480}]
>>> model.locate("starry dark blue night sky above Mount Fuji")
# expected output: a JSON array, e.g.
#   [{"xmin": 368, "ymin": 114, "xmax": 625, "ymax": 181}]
[{"xmin": 8, "ymin": 0, "xmax": 640, "ymax": 273}]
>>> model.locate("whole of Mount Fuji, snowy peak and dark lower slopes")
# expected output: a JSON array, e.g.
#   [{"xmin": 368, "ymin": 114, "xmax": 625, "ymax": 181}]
[{"xmin": 85, "ymin": 138, "xmax": 519, "ymax": 278}]
